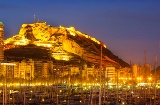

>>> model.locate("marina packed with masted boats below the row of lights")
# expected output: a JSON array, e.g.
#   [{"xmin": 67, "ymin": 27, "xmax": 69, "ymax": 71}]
[{"xmin": 0, "ymin": 83, "xmax": 160, "ymax": 105}]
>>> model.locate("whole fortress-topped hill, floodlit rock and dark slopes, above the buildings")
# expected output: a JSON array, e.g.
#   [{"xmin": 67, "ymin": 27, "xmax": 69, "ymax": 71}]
[{"xmin": 4, "ymin": 22, "xmax": 129, "ymax": 67}]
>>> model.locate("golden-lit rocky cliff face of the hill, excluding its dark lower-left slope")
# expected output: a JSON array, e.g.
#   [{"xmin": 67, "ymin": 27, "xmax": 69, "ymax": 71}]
[{"xmin": 4, "ymin": 22, "xmax": 129, "ymax": 67}]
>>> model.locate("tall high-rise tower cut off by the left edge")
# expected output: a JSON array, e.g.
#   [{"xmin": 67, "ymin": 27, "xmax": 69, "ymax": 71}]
[{"xmin": 0, "ymin": 22, "xmax": 4, "ymax": 61}]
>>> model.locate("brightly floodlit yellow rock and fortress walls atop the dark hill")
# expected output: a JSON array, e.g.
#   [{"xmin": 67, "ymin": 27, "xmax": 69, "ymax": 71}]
[{"xmin": 4, "ymin": 22, "xmax": 109, "ymax": 63}]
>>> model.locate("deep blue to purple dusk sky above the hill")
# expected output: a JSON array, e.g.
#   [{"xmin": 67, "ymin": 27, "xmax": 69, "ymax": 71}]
[{"xmin": 0, "ymin": 0, "xmax": 160, "ymax": 65}]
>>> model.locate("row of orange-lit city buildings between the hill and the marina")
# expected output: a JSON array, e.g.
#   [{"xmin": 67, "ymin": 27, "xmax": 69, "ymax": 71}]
[{"xmin": 0, "ymin": 56, "xmax": 154, "ymax": 84}]
